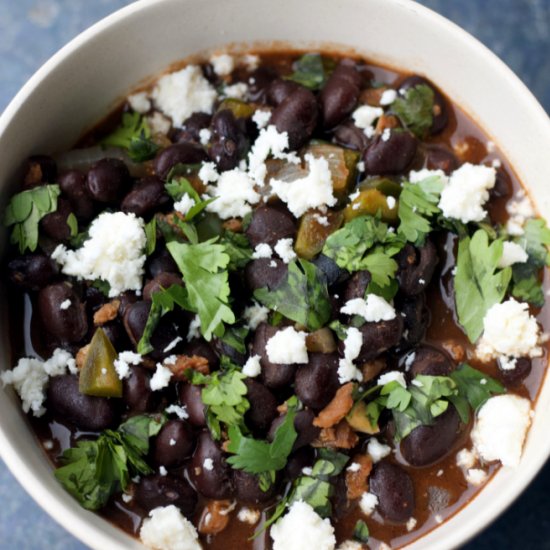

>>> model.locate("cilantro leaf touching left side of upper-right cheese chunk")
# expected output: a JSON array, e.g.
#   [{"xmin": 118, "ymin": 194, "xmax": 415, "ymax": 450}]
[{"xmin": 397, "ymin": 176, "xmax": 445, "ymax": 246}]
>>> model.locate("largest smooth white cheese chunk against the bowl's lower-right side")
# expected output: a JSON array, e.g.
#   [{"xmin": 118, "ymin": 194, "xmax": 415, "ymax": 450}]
[{"xmin": 471, "ymin": 394, "xmax": 531, "ymax": 467}]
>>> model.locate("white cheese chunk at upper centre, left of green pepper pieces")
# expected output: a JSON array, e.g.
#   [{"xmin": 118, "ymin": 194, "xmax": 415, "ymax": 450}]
[{"xmin": 271, "ymin": 153, "xmax": 336, "ymax": 218}]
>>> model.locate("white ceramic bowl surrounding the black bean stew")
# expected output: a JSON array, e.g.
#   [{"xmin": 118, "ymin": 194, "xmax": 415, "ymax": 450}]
[{"xmin": 0, "ymin": 0, "xmax": 550, "ymax": 550}]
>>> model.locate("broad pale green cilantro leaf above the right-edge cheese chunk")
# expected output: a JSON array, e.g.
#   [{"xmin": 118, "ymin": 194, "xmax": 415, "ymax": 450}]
[{"xmin": 454, "ymin": 229, "xmax": 512, "ymax": 342}]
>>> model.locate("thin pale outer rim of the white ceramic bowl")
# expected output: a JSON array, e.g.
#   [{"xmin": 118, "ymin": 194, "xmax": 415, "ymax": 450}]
[{"xmin": 0, "ymin": 0, "xmax": 550, "ymax": 550}]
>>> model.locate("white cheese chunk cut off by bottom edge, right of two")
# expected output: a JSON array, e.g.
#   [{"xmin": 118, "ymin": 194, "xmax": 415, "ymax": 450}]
[{"xmin": 270, "ymin": 500, "xmax": 336, "ymax": 550}]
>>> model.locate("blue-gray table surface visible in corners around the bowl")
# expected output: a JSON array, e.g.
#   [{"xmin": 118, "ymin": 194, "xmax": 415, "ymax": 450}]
[{"xmin": 0, "ymin": 0, "xmax": 550, "ymax": 550}]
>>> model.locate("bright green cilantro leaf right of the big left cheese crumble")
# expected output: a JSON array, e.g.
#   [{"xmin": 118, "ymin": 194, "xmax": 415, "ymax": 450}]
[{"xmin": 166, "ymin": 239, "xmax": 235, "ymax": 340}]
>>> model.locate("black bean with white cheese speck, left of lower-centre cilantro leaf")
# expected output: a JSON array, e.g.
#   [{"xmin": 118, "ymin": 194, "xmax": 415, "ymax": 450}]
[{"xmin": 187, "ymin": 432, "xmax": 233, "ymax": 500}]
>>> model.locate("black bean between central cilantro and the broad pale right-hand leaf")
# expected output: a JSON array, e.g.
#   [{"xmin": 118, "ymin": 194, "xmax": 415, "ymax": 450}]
[{"xmin": 396, "ymin": 240, "xmax": 439, "ymax": 296}]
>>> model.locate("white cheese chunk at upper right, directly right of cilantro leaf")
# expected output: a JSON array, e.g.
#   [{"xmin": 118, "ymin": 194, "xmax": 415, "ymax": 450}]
[{"xmin": 439, "ymin": 162, "xmax": 496, "ymax": 223}]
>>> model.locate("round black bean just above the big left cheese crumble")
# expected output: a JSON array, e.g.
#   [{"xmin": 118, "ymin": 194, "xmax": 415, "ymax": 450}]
[{"xmin": 87, "ymin": 159, "xmax": 130, "ymax": 203}]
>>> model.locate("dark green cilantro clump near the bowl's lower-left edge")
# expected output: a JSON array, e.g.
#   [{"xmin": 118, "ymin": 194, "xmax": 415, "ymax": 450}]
[{"xmin": 55, "ymin": 416, "xmax": 166, "ymax": 510}]
